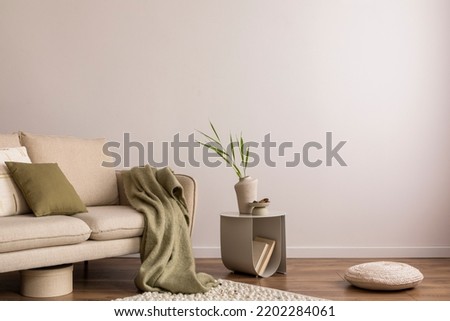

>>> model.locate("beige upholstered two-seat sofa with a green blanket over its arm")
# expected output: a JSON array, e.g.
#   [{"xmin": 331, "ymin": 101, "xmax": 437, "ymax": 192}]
[{"xmin": 0, "ymin": 133, "xmax": 196, "ymax": 273}]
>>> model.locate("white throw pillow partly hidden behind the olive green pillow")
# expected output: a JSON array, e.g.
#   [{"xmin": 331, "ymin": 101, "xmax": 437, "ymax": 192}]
[{"xmin": 0, "ymin": 147, "xmax": 31, "ymax": 216}]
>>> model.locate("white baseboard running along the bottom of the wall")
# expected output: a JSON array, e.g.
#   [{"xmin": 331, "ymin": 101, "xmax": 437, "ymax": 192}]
[{"xmin": 194, "ymin": 246, "xmax": 450, "ymax": 258}]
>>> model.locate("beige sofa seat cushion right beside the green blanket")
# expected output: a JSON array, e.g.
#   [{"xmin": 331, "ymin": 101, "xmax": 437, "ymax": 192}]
[{"xmin": 74, "ymin": 205, "xmax": 144, "ymax": 241}]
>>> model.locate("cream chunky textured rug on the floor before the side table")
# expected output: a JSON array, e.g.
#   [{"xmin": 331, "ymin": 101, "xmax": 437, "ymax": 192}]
[{"xmin": 116, "ymin": 279, "xmax": 324, "ymax": 301}]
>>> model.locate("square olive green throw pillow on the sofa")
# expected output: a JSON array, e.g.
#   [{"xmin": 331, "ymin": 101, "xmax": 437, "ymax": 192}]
[{"xmin": 5, "ymin": 162, "xmax": 87, "ymax": 216}]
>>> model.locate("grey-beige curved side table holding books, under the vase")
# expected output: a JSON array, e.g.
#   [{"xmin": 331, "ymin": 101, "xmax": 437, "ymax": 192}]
[{"xmin": 220, "ymin": 212, "xmax": 286, "ymax": 277}]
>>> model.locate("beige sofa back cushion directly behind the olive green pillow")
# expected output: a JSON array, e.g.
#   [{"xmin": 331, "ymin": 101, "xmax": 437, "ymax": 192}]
[{"xmin": 20, "ymin": 132, "xmax": 119, "ymax": 206}]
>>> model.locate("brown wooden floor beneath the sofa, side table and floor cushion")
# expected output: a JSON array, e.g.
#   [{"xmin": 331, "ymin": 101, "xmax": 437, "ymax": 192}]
[{"xmin": 0, "ymin": 258, "xmax": 450, "ymax": 301}]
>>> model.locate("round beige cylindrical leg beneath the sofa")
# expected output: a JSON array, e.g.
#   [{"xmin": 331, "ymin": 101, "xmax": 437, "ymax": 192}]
[{"xmin": 20, "ymin": 264, "xmax": 73, "ymax": 298}]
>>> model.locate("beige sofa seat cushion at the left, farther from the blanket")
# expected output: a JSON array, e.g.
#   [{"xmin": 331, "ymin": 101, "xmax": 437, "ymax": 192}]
[{"xmin": 0, "ymin": 214, "xmax": 91, "ymax": 253}]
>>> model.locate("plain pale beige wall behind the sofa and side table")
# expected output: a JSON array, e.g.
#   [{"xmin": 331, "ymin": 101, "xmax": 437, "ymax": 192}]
[{"xmin": 0, "ymin": 0, "xmax": 450, "ymax": 257}]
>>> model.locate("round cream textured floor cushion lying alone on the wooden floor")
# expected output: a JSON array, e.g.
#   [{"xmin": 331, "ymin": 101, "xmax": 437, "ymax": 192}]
[{"xmin": 344, "ymin": 261, "xmax": 423, "ymax": 291}]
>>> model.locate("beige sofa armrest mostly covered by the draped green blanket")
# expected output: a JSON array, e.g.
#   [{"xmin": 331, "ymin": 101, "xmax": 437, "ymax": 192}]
[{"xmin": 116, "ymin": 170, "xmax": 197, "ymax": 236}]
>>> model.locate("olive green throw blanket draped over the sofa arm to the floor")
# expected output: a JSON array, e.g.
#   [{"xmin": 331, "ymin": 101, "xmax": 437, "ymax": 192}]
[{"xmin": 123, "ymin": 165, "xmax": 217, "ymax": 294}]
